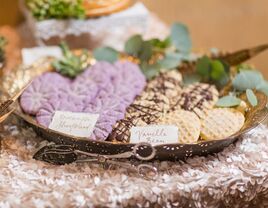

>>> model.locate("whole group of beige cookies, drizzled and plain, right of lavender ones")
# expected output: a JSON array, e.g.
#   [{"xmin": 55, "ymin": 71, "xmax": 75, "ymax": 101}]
[{"xmin": 109, "ymin": 70, "xmax": 245, "ymax": 144}]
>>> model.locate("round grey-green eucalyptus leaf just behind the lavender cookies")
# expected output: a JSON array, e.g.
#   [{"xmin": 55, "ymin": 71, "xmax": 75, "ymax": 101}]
[{"xmin": 93, "ymin": 47, "xmax": 119, "ymax": 63}]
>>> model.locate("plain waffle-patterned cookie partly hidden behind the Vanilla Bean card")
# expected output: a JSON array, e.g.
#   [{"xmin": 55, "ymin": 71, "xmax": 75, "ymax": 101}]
[{"xmin": 159, "ymin": 110, "xmax": 201, "ymax": 144}]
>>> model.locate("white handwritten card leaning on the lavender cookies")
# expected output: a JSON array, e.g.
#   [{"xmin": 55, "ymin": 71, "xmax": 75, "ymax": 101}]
[{"xmin": 49, "ymin": 111, "xmax": 99, "ymax": 137}]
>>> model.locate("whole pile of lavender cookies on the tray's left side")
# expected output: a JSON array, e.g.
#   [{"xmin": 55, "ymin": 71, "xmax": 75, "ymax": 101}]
[{"xmin": 20, "ymin": 62, "xmax": 146, "ymax": 140}]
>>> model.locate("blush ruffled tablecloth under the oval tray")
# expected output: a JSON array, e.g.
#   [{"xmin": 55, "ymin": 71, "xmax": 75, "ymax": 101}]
[{"xmin": 0, "ymin": 116, "xmax": 268, "ymax": 208}]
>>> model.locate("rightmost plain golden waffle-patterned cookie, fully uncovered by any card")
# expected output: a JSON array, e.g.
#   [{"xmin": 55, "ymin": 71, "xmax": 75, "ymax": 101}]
[{"xmin": 201, "ymin": 108, "xmax": 245, "ymax": 140}]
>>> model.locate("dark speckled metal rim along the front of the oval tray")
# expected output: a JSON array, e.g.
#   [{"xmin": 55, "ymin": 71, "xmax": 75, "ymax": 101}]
[{"xmin": 14, "ymin": 92, "xmax": 268, "ymax": 163}]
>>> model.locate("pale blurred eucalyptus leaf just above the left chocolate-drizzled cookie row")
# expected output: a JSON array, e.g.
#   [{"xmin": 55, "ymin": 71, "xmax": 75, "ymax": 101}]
[{"xmin": 158, "ymin": 52, "xmax": 183, "ymax": 69}]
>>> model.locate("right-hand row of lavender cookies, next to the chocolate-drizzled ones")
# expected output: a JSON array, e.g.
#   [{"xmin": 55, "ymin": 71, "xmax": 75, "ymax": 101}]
[{"xmin": 82, "ymin": 62, "xmax": 146, "ymax": 140}]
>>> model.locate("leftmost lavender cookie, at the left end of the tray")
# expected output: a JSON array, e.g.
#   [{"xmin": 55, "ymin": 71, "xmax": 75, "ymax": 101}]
[{"xmin": 20, "ymin": 72, "xmax": 70, "ymax": 115}]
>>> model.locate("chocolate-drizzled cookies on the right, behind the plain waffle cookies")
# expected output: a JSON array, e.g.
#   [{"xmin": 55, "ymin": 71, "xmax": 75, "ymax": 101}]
[{"xmin": 173, "ymin": 83, "xmax": 219, "ymax": 118}]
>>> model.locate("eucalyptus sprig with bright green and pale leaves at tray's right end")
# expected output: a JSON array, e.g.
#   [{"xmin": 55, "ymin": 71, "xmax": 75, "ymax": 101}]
[{"xmin": 184, "ymin": 56, "xmax": 268, "ymax": 107}]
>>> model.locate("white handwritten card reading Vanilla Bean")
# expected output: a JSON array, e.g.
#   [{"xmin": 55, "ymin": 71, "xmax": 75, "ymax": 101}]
[{"xmin": 130, "ymin": 125, "xmax": 179, "ymax": 145}]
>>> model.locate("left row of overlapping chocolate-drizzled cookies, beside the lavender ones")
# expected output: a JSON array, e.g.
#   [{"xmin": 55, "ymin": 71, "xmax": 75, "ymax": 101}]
[{"xmin": 109, "ymin": 70, "xmax": 182, "ymax": 142}]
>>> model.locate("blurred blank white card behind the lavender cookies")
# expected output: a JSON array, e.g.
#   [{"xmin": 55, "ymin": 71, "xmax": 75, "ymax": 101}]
[{"xmin": 21, "ymin": 46, "xmax": 62, "ymax": 65}]
